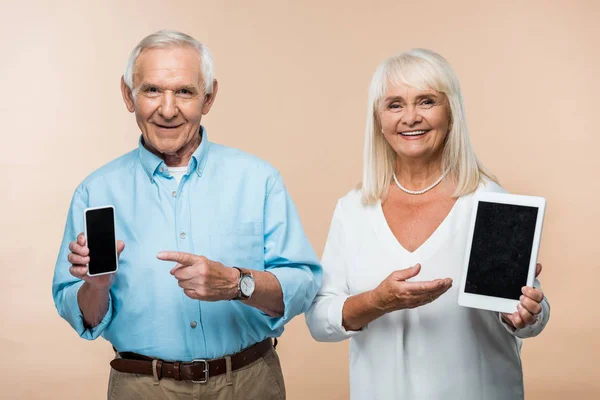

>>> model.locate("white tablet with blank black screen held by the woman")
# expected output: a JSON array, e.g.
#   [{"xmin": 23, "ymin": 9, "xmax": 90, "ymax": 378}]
[{"xmin": 458, "ymin": 193, "xmax": 546, "ymax": 313}]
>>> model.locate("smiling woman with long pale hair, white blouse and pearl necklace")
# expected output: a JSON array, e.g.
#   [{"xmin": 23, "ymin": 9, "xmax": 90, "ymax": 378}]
[{"xmin": 306, "ymin": 49, "xmax": 550, "ymax": 400}]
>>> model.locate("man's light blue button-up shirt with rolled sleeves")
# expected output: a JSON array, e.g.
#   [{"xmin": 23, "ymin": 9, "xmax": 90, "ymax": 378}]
[{"xmin": 52, "ymin": 130, "xmax": 322, "ymax": 361}]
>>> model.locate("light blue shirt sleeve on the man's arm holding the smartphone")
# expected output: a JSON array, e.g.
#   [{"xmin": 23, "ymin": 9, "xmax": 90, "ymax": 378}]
[{"xmin": 52, "ymin": 186, "xmax": 112, "ymax": 340}]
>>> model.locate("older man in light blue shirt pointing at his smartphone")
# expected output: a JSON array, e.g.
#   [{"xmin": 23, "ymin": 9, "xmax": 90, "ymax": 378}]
[{"xmin": 52, "ymin": 31, "xmax": 321, "ymax": 400}]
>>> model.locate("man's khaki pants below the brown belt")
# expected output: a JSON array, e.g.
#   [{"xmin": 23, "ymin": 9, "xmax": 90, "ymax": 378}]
[{"xmin": 108, "ymin": 349, "xmax": 285, "ymax": 400}]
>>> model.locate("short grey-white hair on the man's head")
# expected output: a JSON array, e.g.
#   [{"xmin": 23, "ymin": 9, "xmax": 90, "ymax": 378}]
[{"xmin": 123, "ymin": 29, "xmax": 214, "ymax": 95}]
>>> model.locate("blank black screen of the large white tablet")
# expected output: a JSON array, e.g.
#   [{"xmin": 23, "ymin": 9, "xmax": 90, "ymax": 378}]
[{"xmin": 465, "ymin": 201, "xmax": 538, "ymax": 300}]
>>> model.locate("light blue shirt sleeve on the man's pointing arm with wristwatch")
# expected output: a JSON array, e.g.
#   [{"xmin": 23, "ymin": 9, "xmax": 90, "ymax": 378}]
[{"xmin": 263, "ymin": 174, "xmax": 322, "ymax": 330}]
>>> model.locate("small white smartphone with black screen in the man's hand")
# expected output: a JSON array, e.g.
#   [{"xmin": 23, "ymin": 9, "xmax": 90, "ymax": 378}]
[{"xmin": 83, "ymin": 206, "xmax": 118, "ymax": 276}]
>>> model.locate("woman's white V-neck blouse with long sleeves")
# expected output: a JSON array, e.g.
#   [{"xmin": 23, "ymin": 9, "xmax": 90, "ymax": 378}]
[{"xmin": 306, "ymin": 183, "xmax": 550, "ymax": 400}]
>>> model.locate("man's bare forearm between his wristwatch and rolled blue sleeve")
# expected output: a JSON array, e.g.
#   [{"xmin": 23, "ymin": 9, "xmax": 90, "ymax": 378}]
[{"xmin": 243, "ymin": 270, "xmax": 285, "ymax": 317}]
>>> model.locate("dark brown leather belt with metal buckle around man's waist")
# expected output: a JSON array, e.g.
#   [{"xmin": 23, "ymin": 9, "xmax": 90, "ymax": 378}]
[{"xmin": 110, "ymin": 338, "xmax": 273, "ymax": 383}]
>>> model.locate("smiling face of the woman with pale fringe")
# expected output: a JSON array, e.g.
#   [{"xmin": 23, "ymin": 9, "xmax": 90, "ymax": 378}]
[{"xmin": 378, "ymin": 84, "xmax": 450, "ymax": 161}]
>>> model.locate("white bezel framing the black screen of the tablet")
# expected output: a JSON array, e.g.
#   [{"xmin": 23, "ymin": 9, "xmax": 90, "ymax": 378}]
[{"xmin": 458, "ymin": 192, "xmax": 546, "ymax": 313}]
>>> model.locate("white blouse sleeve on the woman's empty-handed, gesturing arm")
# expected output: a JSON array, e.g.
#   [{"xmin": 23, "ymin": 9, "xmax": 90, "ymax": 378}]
[{"xmin": 306, "ymin": 202, "xmax": 368, "ymax": 342}]
